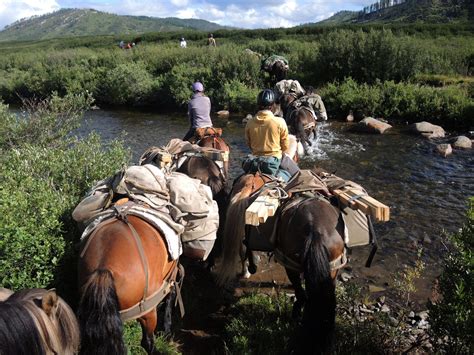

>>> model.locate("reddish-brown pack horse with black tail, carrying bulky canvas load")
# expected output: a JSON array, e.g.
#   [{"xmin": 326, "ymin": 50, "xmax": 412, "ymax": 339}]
[{"xmin": 78, "ymin": 216, "xmax": 178, "ymax": 354}]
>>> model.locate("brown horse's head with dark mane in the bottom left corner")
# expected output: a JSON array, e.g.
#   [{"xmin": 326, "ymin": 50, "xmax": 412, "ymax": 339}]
[{"xmin": 0, "ymin": 288, "xmax": 80, "ymax": 355}]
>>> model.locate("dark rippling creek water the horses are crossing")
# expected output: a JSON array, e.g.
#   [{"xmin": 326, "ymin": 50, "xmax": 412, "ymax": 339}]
[{"xmin": 80, "ymin": 110, "xmax": 474, "ymax": 304}]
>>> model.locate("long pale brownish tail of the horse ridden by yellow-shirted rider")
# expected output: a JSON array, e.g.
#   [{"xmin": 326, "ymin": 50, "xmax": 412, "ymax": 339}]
[{"xmin": 217, "ymin": 188, "xmax": 252, "ymax": 285}]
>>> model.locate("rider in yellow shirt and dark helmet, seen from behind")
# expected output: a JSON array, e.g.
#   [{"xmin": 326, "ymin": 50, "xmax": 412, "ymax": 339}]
[{"xmin": 245, "ymin": 89, "xmax": 298, "ymax": 180}]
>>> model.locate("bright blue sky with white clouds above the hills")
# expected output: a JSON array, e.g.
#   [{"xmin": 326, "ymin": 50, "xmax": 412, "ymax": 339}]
[{"xmin": 0, "ymin": 0, "xmax": 375, "ymax": 29}]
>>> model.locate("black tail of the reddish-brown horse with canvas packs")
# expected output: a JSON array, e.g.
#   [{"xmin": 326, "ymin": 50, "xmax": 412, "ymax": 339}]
[{"xmin": 77, "ymin": 269, "xmax": 127, "ymax": 355}]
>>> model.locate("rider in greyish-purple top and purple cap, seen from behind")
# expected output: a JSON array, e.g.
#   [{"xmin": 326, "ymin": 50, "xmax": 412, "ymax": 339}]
[{"xmin": 183, "ymin": 81, "xmax": 212, "ymax": 141}]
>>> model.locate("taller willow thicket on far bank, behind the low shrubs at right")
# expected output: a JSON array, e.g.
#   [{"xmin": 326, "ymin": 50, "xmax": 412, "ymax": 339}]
[{"xmin": 317, "ymin": 29, "xmax": 473, "ymax": 83}]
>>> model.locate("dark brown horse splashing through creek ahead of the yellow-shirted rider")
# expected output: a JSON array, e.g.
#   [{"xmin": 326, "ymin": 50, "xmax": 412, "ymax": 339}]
[{"xmin": 280, "ymin": 94, "xmax": 316, "ymax": 153}]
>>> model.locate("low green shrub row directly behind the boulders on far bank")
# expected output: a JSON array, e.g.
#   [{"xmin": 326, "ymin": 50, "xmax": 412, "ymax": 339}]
[{"xmin": 321, "ymin": 78, "xmax": 474, "ymax": 128}]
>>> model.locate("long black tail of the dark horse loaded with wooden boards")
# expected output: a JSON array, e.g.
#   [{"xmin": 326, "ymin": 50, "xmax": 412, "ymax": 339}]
[{"xmin": 303, "ymin": 231, "xmax": 336, "ymax": 353}]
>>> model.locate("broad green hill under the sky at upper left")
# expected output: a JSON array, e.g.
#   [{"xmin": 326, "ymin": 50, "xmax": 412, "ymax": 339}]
[{"xmin": 0, "ymin": 9, "xmax": 230, "ymax": 41}]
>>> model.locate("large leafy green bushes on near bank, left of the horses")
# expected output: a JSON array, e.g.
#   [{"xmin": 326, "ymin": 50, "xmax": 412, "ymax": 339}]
[{"xmin": 0, "ymin": 95, "xmax": 130, "ymax": 289}]
